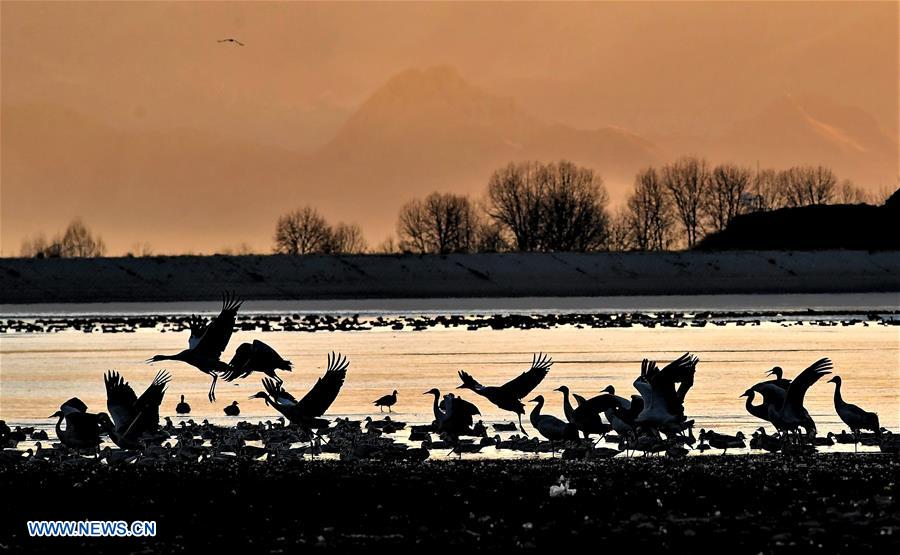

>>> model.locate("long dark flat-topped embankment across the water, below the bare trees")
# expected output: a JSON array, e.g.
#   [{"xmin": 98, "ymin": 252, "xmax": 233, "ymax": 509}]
[{"xmin": 0, "ymin": 251, "xmax": 900, "ymax": 304}]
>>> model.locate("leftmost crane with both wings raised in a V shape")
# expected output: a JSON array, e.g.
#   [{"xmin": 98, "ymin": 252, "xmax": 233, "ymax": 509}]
[{"xmin": 103, "ymin": 370, "xmax": 171, "ymax": 449}]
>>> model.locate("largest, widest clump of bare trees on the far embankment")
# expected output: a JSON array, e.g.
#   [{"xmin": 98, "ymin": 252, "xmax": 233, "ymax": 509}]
[{"xmin": 488, "ymin": 160, "xmax": 608, "ymax": 251}]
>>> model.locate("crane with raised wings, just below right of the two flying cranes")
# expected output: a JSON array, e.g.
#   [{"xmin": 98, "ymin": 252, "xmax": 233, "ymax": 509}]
[{"xmin": 251, "ymin": 353, "xmax": 350, "ymax": 428}]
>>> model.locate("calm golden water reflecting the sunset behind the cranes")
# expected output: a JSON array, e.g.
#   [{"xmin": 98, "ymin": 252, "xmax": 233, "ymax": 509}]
[{"xmin": 0, "ymin": 295, "xmax": 900, "ymax": 456}]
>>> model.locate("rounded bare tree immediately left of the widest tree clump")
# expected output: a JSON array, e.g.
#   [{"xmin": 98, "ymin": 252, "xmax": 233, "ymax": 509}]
[{"xmin": 397, "ymin": 193, "xmax": 480, "ymax": 254}]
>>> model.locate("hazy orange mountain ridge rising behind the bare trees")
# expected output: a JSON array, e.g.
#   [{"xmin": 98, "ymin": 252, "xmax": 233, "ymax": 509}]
[{"xmin": 2, "ymin": 66, "xmax": 897, "ymax": 253}]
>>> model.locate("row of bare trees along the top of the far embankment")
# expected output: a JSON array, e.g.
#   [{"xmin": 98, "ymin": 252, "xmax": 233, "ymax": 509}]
[{"xmin": 21, "ymin": 157, "xmax": 879, "ymax": 257}]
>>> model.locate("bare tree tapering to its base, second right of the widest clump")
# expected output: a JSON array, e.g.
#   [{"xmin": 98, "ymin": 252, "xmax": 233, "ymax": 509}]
[{"xmin": 662, "ymin": 157, "xmax": 710, "ymax": 248}]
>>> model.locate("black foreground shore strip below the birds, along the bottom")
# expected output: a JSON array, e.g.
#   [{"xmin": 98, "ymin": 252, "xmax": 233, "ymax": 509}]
[{"xmin": 0, "ymin": 454, "xmax": 900, "ymax": 553}]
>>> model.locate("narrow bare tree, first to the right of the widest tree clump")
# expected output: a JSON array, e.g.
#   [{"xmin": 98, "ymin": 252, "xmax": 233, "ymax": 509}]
[{"xmin": 625, "ymin": 167, "xmax": 675, "ymax": 250}]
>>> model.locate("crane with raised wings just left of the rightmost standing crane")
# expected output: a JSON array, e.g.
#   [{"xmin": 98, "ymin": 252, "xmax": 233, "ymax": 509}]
[{"xmin": 751, "ymin": 358, "xmax": 832, "ymax": 444}]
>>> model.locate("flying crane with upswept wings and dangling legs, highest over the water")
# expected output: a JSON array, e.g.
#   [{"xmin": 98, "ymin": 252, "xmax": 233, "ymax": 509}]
[{"xmin": 147, "ymin": 293, "xmax": 243, "ymax": 402}]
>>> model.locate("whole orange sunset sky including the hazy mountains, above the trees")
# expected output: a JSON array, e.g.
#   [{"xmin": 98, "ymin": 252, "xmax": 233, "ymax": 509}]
[{"xmin": 0, "ymin": 1, "xmax": 900, "ymax": 256}]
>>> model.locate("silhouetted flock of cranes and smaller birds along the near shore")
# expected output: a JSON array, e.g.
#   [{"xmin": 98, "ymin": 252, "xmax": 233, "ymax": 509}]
[{"xmin": 0, "ymin": 293, "xmax": 900, "ymax": 462}]
